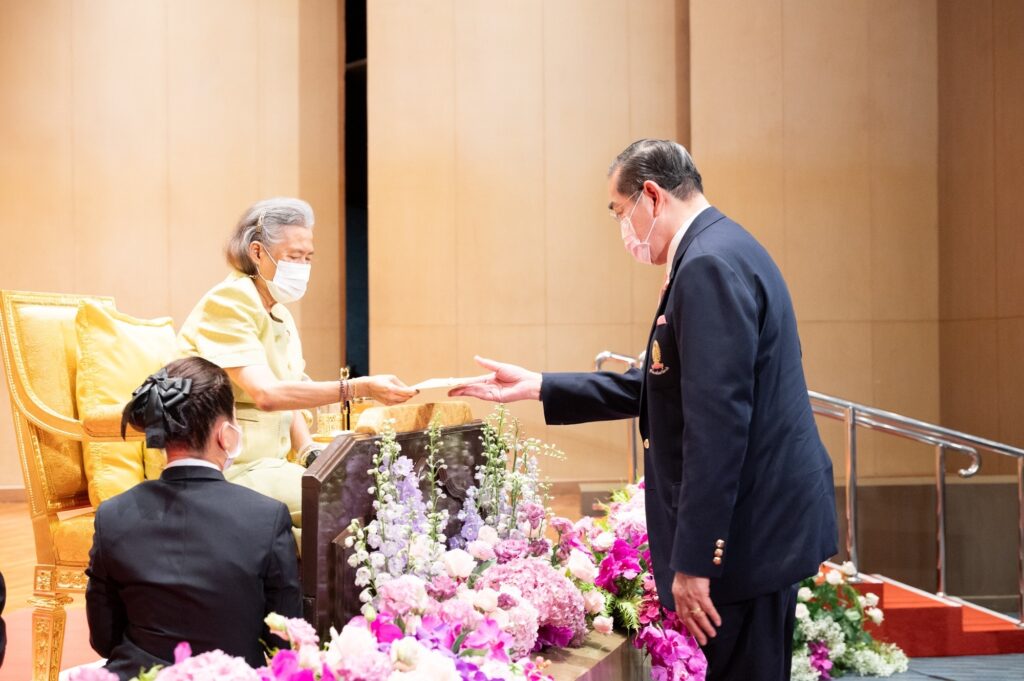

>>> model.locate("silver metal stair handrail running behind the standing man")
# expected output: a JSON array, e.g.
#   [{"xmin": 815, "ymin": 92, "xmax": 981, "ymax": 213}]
[{"xmin": 594, "ymin": 350, "xmax": 1024, "ymax": 628}]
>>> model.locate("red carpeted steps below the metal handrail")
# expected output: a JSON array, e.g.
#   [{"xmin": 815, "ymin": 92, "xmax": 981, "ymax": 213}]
[{"xmin": 824, "ymin": 565, "xmax": 1024, "ymax": 657}]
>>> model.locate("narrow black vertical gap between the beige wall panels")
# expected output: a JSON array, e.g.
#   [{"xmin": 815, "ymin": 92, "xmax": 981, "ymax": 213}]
[{"xmin": 345, "ymin": 0, "xmax": 370, "ymax": 376}]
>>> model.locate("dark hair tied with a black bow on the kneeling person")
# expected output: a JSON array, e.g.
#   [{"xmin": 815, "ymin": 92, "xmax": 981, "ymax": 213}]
[{"xmin": 121, "ymin": 357, "xmax": 234, "ymax": 452}]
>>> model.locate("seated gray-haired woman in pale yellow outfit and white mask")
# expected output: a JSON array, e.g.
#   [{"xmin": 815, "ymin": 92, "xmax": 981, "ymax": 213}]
[{"xmin": 178, "ymin": 199, "xmax": 416, "ymax": 526}]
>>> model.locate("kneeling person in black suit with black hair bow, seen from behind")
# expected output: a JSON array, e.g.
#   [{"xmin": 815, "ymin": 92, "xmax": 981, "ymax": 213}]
[{"xmin": 85, "ymin": 357, "xmax": 301, "ymax": 679}]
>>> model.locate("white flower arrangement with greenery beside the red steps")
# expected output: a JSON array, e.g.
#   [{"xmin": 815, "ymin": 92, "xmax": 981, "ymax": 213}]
[{"xmin": 792, "ymin": 561, "xmax": 907, "ymax": 681}]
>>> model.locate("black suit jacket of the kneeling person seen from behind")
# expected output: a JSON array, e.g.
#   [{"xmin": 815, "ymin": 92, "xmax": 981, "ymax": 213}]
[{"xmin": 85, "ymin": 466, "xmax": 301, "ymax": 679}]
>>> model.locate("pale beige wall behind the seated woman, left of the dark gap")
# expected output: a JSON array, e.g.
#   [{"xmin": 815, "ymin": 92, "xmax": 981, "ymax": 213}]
[{"xmin": 0, "ymin": 0, "xmax": 342, "ymax": 486}]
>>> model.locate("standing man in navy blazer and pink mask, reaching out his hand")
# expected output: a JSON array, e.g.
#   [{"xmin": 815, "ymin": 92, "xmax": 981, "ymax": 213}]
[{"xmin": 453, "ymin": 139, "xmax": 837, "ymax": 681}]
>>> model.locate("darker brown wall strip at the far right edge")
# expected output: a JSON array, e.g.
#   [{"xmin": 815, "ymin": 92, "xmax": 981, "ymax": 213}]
[{"xmin": 938, "ymin": 0, "xmax": 1024, "ymax": 473}]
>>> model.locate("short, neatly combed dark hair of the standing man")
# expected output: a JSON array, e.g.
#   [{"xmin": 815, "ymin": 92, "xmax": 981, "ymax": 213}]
[{"xmin": 608, "ymin": 139, "xmax": 703, "ymax": 201}]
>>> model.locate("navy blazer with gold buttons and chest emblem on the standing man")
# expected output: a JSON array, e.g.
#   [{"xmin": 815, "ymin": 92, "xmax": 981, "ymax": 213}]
[{"xmin": 541, "ymin": 208, "xmax": 837, "ymax": 609}]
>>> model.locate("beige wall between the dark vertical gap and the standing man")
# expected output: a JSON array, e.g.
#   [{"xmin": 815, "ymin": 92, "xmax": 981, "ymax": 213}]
[{"xmin": 368, "ymin": 0, "xmax": 680, "ymax": 480}]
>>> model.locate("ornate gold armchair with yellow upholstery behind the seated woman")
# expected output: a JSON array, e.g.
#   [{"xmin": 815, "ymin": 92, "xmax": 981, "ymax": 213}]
[{"xmin": 0, "ymin": 291, "xmax": 141, "ymax": 681}]
